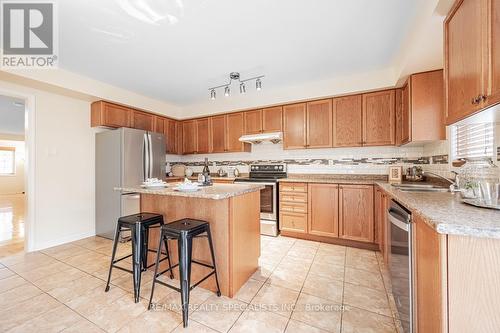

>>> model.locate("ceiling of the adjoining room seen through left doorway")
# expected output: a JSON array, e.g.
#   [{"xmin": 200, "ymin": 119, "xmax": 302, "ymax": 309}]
[{"xmin": 0, "ymin": 95, "xmax": 24, "ymax": 135}]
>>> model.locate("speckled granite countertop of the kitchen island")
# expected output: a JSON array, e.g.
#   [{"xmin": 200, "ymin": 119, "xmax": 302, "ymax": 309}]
[{"xmin": 115, "ymin": 184, "xmax": 264, "ymax": 200}]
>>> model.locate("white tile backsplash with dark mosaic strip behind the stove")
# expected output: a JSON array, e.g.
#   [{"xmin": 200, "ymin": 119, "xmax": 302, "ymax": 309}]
[{"xmin": 167, "ymin": 141, "xmax": 448, "ymax": 174}]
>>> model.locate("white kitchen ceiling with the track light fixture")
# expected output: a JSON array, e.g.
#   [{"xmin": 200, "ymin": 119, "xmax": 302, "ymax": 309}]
[{"xmin": 58, "ymin": 0, "xmax": 420, "ymax": 106}]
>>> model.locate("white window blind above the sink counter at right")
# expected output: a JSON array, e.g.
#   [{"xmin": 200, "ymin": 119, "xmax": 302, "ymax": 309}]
[{"xmin": 454, "ymin": 123, "xmax": 494, "ymax": 159}]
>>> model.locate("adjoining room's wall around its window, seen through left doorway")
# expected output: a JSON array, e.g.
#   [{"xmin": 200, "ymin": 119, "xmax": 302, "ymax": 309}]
[{"xmin": 0, "ymin": 134, "xmax": 24, "ymax": 194}]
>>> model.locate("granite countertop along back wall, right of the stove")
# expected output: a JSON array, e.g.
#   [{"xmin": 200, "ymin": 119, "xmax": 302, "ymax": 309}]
[{"xmin": 278, "ymin": 173, "xmax": 387, "ymax": 185}]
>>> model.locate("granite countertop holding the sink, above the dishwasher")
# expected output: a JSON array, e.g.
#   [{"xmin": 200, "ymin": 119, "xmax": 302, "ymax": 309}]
[{"xmin": 377, "ymin": 182, "xmax": 500, "ymax": 239}]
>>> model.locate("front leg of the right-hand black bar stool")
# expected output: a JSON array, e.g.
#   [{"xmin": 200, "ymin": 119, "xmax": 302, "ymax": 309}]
[{"xmin": 178, "ymin": 234, "xmax": 193, "ymax": 327}]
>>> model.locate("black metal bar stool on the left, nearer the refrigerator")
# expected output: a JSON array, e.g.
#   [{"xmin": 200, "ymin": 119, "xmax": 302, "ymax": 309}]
[{"xmin": 105, "ymin": 213, "xmax": 174, "ymax": 303}]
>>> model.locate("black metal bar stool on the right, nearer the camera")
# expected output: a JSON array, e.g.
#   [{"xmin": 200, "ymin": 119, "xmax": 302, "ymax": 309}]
[{"xmin": 148, "ymin": 219, "xmax": 221, "ymax": 327}]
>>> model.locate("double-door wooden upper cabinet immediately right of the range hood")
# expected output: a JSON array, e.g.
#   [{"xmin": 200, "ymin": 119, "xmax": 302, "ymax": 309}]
[{"xmin": 283, "ymin": 99, "xmax": 333, "ymax": 149}]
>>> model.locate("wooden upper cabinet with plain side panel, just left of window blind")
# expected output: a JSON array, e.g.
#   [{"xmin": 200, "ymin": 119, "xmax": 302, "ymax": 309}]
[{"xmin": 396, "ymin": 70, "xmax": 446, "ymax": 145}]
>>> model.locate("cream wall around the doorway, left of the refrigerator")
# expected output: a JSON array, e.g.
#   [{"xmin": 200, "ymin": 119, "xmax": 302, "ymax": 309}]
[{"xmin": 0, "ymin": 81, "xmax": 95, "ymax": 250}]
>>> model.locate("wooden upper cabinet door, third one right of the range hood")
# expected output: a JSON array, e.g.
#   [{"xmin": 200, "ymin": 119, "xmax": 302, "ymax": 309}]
[{"xmin": 332, "ymin": 95, "xmax": 363, "ymax": 147}]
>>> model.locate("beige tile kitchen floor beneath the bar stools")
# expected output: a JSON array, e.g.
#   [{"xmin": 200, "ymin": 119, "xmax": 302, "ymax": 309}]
[{"xmin": 0, "ymin": 233, "xmax": 397, "ymax": 333}]
